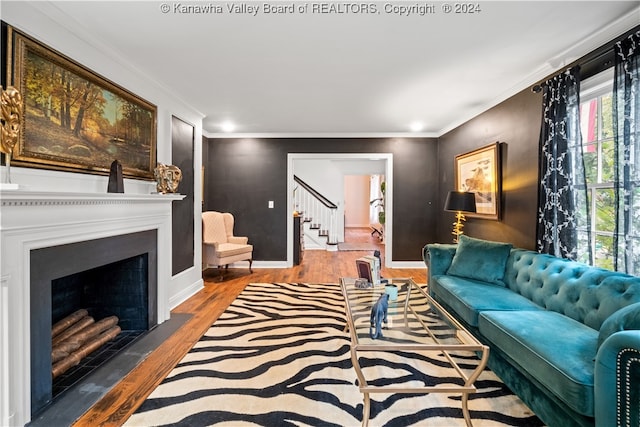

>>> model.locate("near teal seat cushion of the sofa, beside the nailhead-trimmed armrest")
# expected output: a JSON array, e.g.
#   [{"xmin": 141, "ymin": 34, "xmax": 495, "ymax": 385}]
[{"xmin": 478, "ymin": 310, "xmax": 598, "ymax": 417}]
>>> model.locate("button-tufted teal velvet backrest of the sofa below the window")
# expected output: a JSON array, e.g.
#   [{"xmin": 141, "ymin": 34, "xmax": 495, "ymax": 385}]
[{"xmin": 504, "ymin": 249, "xmax": 640, "ymax": 330}]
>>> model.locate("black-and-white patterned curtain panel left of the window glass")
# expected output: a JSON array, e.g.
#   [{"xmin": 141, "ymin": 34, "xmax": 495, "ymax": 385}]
[{"xmin": 537, "ymin": 67, "xmax": 591, "ymax": 262}]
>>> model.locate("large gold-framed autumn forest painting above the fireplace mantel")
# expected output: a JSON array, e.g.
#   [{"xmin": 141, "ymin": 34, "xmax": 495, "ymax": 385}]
[{"xmin": 7, "ymin": 27, "xmax": 157, "ymax": 180}]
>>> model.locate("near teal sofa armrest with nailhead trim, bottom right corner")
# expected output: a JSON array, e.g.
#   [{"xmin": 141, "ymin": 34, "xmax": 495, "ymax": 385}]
[{"xmin": 594, "ymin": 330, "xmax": 640, "ymax": 427}]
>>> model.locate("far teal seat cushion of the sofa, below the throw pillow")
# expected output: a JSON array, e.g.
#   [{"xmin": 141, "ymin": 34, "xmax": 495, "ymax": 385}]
[{"xmin": 429, "ymin": 276, "xmax": 541, "ymax": 327}]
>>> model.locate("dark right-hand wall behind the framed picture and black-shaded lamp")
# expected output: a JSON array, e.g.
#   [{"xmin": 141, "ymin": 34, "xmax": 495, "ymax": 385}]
[{"xmin": 436, "ymin": 90, "xmax": 542, "ymax": 249}]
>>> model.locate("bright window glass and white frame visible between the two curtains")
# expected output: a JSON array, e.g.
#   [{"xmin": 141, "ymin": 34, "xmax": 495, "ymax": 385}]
[{"xmin": 578, "ymin": 69, "xmax": 615, "ymax": 270}]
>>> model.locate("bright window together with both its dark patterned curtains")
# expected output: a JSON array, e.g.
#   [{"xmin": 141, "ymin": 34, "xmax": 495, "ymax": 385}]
[{"xmin": 536, "ymin": 32, "xmax": 640, "ymax": 276}]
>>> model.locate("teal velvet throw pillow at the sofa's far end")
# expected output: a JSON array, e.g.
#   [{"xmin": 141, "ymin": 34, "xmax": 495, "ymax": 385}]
[{"xmin": 447, "ymin": 234, "xmax": 513, "ymax": 285}]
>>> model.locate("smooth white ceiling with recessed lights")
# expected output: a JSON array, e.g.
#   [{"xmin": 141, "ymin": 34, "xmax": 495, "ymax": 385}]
[{"xmin": 6, "ymin": 0, "xmax": 640, "ymax": 136}]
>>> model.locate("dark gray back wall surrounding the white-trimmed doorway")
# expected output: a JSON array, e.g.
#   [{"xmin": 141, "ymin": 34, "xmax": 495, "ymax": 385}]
[{"xmin": 203, "ymin": 138, "xmax": 440, "ymax": 261}]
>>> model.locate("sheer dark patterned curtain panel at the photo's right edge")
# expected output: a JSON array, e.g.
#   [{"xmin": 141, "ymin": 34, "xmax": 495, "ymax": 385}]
[{"xmin": 613, "ymin": 32, "xmax": 640, "ymax": 275}]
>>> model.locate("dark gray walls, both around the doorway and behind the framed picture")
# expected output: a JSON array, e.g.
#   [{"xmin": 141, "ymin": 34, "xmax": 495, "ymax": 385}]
[{"xmin": 203, "ymin": 90, "xmax": 542, "ymax": 261}]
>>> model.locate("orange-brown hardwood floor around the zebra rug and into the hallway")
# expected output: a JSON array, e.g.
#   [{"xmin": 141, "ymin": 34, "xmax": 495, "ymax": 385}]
[{"xmin": 74, "ymin": 232, "xmax": 427, "ymax": 426}]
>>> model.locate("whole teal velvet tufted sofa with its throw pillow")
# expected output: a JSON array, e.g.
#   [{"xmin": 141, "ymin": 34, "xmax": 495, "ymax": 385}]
[{"xmin": 423, "ymin": 235, "xmax": 640, "ymax": 427}]
